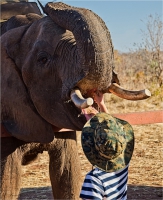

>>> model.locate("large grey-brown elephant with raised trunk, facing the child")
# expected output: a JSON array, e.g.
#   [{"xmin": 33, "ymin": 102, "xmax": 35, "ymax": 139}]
[{"xmin": 1, "ymin": 2, "xmax": 149, "ymax": 200}]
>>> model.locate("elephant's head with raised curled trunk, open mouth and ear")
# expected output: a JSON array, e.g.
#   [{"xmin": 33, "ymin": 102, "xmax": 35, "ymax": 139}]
[{"xmin": 1, "ymin": 3, "xmax": 150, "ymax": 143}]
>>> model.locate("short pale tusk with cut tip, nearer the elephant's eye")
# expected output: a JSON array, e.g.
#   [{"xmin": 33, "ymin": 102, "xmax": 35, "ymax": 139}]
[{"xmin": 70, "ymin": 89, "xmax": 93, "ymax": 109}]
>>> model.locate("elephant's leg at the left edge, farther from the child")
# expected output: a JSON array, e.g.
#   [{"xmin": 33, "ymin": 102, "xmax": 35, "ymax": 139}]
[{"xmin": 1, "ymin": 137, "xmax": 24, "ymax": 200}]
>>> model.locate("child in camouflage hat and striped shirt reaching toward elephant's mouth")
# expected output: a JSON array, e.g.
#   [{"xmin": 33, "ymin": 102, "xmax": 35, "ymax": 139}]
[{"xmin": 80, "ymin": 93, "xmax": 134, "ymax": 200}]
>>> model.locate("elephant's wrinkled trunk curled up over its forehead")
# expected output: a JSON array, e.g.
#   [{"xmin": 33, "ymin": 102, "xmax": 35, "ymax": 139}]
[{"xmin": 45, "ymin": 2, "xmax": 113, "ymax": 94}]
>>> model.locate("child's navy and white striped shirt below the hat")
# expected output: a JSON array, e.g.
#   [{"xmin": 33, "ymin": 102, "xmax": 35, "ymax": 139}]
[{"xmin": 80, "ymin": 166, "xmax": 128, "ymax": 200}]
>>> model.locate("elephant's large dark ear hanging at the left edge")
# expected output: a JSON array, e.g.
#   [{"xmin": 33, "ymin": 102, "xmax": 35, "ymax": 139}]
[{"xmin": 1, "ymin": 27, "xmax": 54, "ymax": 143}]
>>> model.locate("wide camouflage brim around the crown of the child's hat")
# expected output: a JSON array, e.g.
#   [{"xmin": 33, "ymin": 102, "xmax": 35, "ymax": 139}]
[{"xmin": 81, "ymin": 113, "xmax": 134, "ymax": 172}]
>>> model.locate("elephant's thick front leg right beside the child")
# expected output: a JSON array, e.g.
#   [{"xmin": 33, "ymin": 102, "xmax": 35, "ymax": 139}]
[{"xmin": 49, "ymin": 131, "xmax": 81, "ymax": 200}]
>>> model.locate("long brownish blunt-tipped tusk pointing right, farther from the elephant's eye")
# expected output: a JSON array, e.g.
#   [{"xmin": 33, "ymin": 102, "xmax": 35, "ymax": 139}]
[{"xmin": 104, "ymin": 83, "xmax": 151, "ymax": 101}]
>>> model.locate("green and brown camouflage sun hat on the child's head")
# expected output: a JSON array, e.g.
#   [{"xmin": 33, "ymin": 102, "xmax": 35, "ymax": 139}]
[{"xmin": 81, "ymin": 113, "xmax": 134, "ymax": 172}]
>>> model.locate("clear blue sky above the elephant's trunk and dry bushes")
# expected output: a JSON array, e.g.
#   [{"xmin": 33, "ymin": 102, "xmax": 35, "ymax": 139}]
[{"xmin": 32, "ymin": 0, "xmax": 163, "ymax": 52}]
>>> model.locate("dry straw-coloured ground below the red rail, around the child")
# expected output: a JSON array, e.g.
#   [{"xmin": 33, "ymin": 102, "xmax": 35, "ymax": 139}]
[{"xmin": 18, "ymin": 124, "xmax": 163, "ymax": 200}]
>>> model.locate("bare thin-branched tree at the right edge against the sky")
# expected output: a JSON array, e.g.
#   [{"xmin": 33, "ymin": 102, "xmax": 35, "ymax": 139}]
[{"xmin": 135, "ymin": 14, "xmax": 163, "ymax": 86}]
